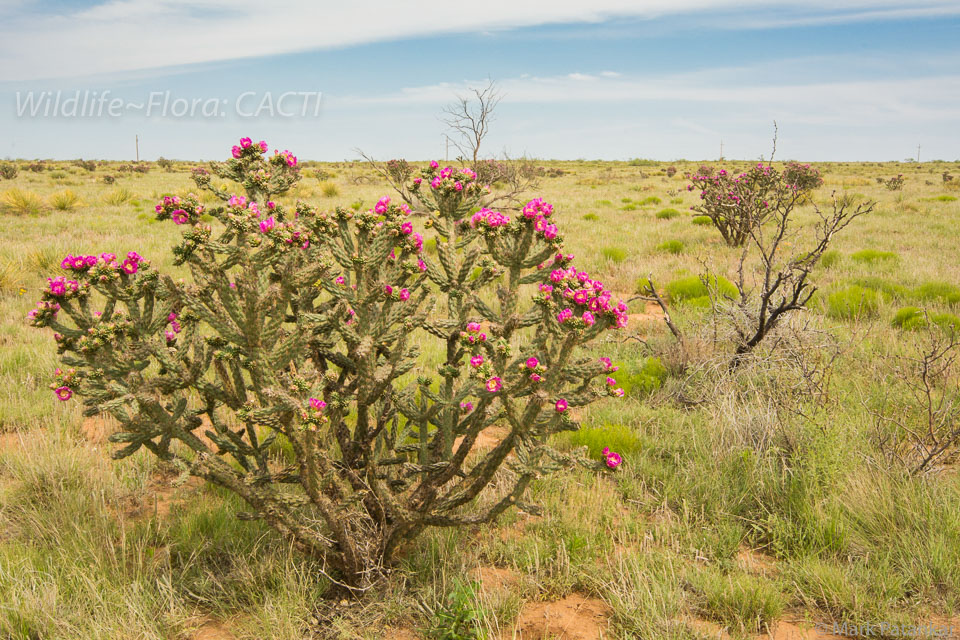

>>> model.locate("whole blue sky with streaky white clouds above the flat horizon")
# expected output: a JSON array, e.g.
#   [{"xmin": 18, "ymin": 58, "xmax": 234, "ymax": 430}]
[{"xmin": 0, "ymin": 0, "xmax": 960, "ymax": 161}]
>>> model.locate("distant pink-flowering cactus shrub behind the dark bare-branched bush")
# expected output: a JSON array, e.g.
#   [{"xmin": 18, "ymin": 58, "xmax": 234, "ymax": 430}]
[{"xmin": 687, "ymin": 162, "xmax": 819, "ymax": 247}]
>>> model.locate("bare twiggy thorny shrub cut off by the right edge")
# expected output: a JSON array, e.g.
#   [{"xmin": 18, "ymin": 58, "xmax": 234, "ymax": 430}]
[{"xmin": 861, "ymin": 327, "xmax": 960, "ymax": 475}]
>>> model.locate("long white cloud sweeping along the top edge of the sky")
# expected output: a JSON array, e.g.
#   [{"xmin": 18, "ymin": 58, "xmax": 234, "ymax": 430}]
[{"xmin": 0, "ymin": 0, "xmax": 958, "ymax": 81}]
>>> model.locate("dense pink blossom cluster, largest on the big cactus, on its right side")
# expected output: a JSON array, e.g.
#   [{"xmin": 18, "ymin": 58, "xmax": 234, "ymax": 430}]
[{"xmin": 540, "ymin": 267, "xmax": 628, "ymax": 329}]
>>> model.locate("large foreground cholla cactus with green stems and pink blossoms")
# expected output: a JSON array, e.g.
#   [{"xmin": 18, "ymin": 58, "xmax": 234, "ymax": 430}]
[{"xmin": 30, "ymin": 139, "xmax": 626, "ymax": 590}]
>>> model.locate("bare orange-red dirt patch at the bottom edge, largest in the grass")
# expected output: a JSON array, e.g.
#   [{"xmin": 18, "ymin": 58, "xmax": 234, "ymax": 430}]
[{"xmin": 501, "ymin": 593, "xmax": 612, "ymax": 640}]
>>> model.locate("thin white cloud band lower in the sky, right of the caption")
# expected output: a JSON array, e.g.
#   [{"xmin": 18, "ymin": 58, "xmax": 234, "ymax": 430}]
[{"xmin": 328, "ymin": 67, "xmax": 960, "ymax": 128}]
